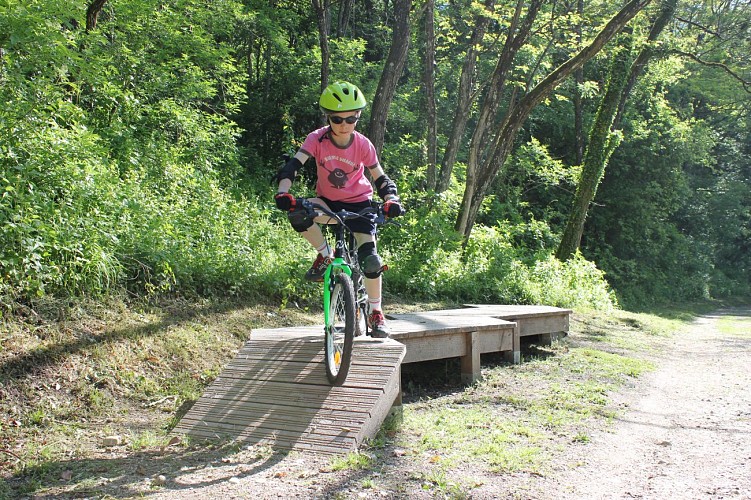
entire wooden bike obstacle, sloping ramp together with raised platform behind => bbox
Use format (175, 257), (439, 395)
(173, 305), (571, 453)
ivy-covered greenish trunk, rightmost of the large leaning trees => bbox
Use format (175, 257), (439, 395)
(556, 35), (631, 260)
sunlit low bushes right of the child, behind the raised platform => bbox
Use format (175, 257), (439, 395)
(379, 197), (617, 309)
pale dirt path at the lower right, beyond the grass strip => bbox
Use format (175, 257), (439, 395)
(531, 309), (751, 499)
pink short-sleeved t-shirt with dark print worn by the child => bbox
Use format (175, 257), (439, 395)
(300, 127), (378, 203)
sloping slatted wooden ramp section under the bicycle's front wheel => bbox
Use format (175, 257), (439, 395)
(173, 326), (406, 454)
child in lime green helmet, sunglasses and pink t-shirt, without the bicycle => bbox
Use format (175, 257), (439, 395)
(274, 82), (404, 338)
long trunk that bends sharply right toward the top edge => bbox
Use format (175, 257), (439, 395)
(456, 0), (651, 238)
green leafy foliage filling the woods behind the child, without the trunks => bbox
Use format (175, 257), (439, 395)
(0, 0), (751, 310)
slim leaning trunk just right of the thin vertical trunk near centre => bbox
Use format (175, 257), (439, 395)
(436, 0), (495, 193)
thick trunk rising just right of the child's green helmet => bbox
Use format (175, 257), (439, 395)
(368, 0), (412, 157)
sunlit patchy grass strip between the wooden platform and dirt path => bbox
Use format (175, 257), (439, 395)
(397, 304), (683, 480)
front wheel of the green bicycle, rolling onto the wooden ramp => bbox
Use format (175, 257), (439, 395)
(324, 273), (357, 385)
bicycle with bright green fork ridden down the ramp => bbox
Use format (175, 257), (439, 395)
(298, 199), (396, 385)
